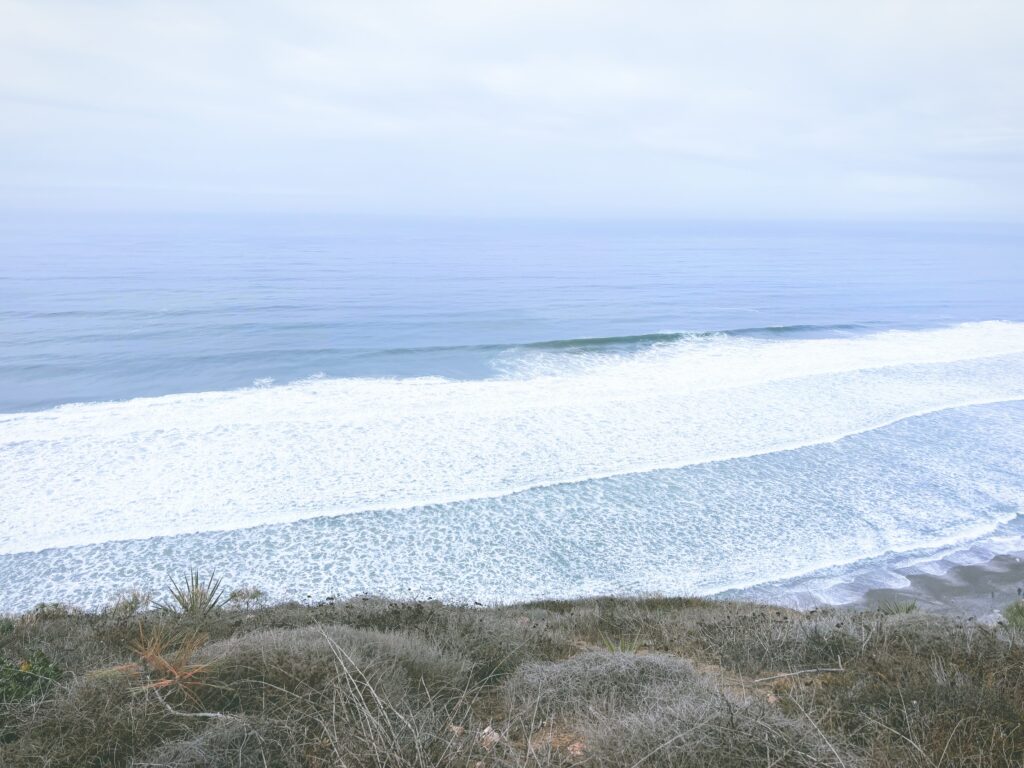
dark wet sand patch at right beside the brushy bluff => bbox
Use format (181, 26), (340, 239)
(855, 553), (1024, 623)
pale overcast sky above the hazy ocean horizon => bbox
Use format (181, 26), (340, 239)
(0, 0), (1024, 221)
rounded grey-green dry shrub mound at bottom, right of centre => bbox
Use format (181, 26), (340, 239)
(505, 651), (841, 767)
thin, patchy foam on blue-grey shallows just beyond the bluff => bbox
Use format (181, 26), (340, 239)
(0, 402), (1024, 610)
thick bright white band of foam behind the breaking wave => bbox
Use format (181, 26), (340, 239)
(0, 323), (1024, 553)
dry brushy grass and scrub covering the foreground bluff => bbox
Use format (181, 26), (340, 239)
(0, 593), (1024, 768)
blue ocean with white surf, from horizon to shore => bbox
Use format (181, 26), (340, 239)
(0, 215), (1024, 610)
